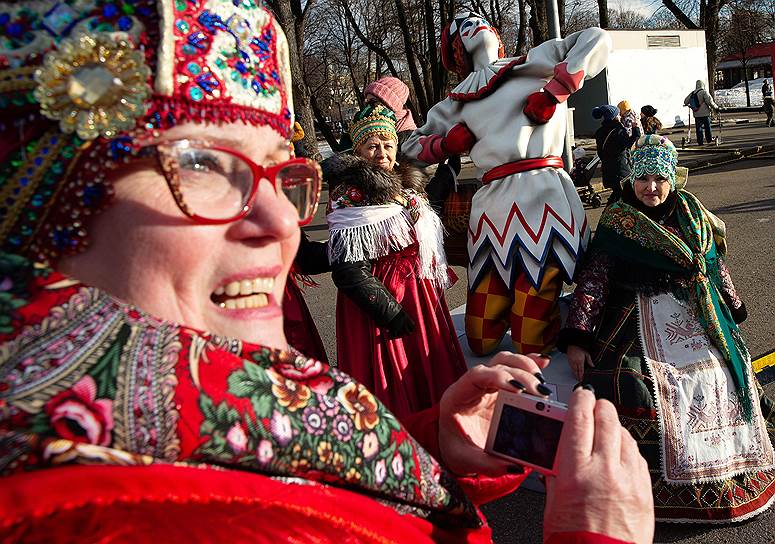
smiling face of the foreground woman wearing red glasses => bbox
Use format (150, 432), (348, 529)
(60, 123), (300, 349)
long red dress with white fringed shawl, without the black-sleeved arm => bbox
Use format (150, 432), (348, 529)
(328, 171), (467, 420)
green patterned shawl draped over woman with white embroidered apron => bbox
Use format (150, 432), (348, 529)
(595, 191), (752, 421)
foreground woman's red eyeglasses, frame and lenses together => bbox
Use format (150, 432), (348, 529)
(149, 140), (323, 226)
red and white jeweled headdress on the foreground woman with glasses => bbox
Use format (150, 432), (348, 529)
(0, 0), (293, 262)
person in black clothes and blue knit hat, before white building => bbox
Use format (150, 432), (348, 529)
(592, 104), (640, 204)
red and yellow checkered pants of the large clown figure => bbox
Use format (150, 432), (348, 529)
(466, 263), (562, 355)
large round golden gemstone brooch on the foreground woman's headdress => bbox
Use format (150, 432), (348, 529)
(35, 33), (151, 140)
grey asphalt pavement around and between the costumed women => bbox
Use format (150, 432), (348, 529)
(305, 114), (775, 544)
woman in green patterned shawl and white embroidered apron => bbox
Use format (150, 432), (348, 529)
(559, 135), (775, 523)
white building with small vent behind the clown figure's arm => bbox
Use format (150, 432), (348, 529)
(569, 30), (708, 135)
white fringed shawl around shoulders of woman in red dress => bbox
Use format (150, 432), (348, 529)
(327, 198), (450, 288)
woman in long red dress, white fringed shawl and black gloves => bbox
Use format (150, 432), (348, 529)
(328, 105), (466, 419)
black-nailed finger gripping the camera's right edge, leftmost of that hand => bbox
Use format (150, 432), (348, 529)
(557, 389), (595, 471)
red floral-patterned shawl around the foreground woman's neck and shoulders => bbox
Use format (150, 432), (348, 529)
(0, 256), (481, 527)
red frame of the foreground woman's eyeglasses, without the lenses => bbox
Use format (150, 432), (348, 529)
(153, 140), (323, 227)
